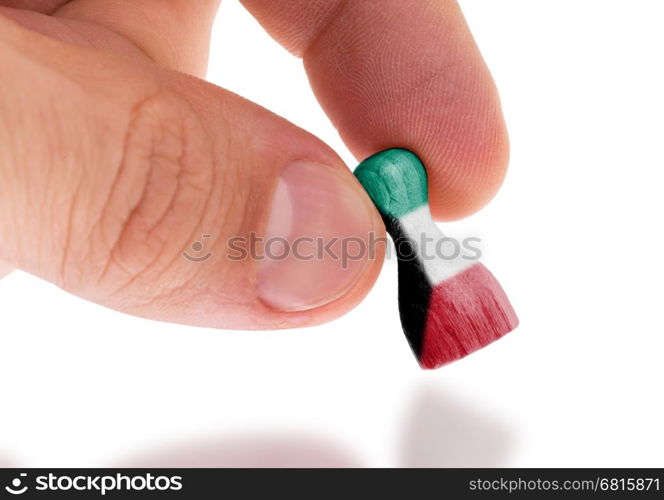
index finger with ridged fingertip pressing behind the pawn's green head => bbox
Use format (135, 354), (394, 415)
(243, 0), (509, 219)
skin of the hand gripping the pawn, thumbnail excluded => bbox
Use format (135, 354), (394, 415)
(0, 0), (508, 329)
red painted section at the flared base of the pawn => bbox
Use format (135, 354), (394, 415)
(419, 262), (519, 369)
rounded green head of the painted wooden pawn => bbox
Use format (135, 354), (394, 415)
(353, 148), (429, 219)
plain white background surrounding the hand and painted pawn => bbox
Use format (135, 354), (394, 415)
(0, 0), (664, 467)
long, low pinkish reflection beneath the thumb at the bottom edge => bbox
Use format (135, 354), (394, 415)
(118, 433), (362, 468)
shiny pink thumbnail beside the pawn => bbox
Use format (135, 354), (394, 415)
(257, 160), (375, 311)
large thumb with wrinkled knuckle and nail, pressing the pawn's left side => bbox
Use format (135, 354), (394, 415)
(0, 21), (384, 328)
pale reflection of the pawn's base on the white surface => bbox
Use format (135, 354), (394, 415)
(398, 385), (514, 467)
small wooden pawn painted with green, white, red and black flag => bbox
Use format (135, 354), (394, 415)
(354, 149), (518, 368)
